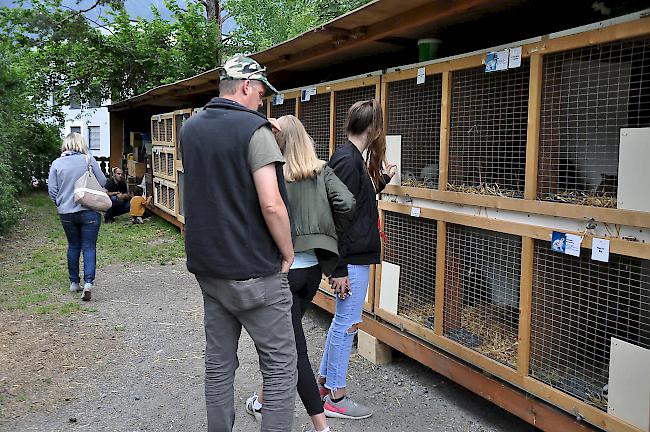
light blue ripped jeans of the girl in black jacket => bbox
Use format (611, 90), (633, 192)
(319, 265), (370, 391)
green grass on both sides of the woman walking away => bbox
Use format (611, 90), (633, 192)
(0, 193), (185, 315)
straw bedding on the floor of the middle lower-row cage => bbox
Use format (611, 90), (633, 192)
(456, 305), (519, 368)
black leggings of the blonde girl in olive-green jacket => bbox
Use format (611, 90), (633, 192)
(289, 265), (323, 416)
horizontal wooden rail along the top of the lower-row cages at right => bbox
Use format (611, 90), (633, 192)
(379, 201), (650, 259)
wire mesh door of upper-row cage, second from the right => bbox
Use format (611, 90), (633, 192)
(448, 59), (530, 198)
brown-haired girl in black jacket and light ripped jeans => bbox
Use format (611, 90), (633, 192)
(318, 100), (394, 419)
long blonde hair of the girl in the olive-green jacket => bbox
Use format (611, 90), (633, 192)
(275, 115), (325, 182)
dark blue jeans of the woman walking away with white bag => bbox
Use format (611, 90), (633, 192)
(59, 210), (102, 283)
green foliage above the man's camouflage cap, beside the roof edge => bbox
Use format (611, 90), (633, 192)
(224, 0), (369, 53)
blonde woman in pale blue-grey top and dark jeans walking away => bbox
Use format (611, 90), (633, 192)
(47, 132), (106, 301)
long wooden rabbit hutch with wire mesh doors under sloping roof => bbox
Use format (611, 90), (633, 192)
(112, 0), (650, 432)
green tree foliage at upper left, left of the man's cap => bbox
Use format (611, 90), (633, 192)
(0, 0), (218, 102)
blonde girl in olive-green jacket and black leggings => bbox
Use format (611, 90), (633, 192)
(246, 115), (355, 432)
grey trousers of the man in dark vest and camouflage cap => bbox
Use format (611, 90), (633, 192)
(196, 273), (297, 432)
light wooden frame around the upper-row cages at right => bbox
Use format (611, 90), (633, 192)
(381, 17), (650, 228)
